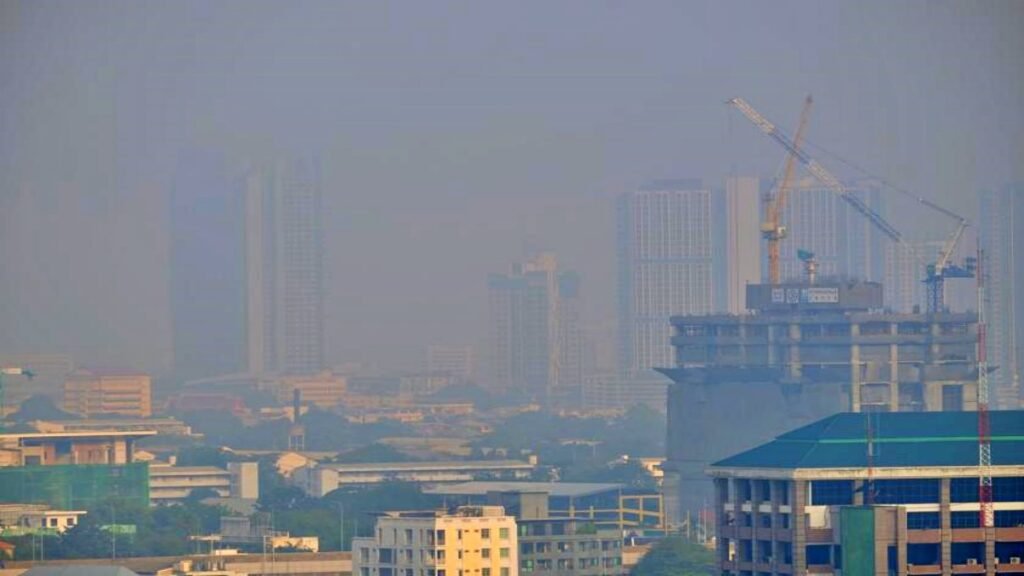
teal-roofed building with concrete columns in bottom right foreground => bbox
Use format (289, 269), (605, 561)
(708, 411), (1024, 576)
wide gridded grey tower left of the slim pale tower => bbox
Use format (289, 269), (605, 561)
(616, 179), (715, 375)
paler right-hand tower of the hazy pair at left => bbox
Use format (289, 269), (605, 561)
(246, 161), (324, 375)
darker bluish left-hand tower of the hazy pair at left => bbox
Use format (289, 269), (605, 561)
(169, 153), (248, 380)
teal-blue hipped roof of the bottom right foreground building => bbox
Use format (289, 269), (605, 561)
(712, 410), (1024, 468)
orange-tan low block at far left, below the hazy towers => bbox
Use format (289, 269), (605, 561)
(63, 370), (153, 417)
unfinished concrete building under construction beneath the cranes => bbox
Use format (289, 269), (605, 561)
(663, 281), (978, 523)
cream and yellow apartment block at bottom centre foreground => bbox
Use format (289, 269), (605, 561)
(352, 506), (519, 576)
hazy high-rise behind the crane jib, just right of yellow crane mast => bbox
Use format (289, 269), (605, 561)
(779, 178), (888, 282)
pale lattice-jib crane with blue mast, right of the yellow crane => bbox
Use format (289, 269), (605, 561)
(726, 98), (977, 313)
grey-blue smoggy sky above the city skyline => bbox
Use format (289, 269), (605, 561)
(0, 0), (1024, 372)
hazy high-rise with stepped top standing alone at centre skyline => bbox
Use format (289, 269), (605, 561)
(487, 253), (583, 401)
